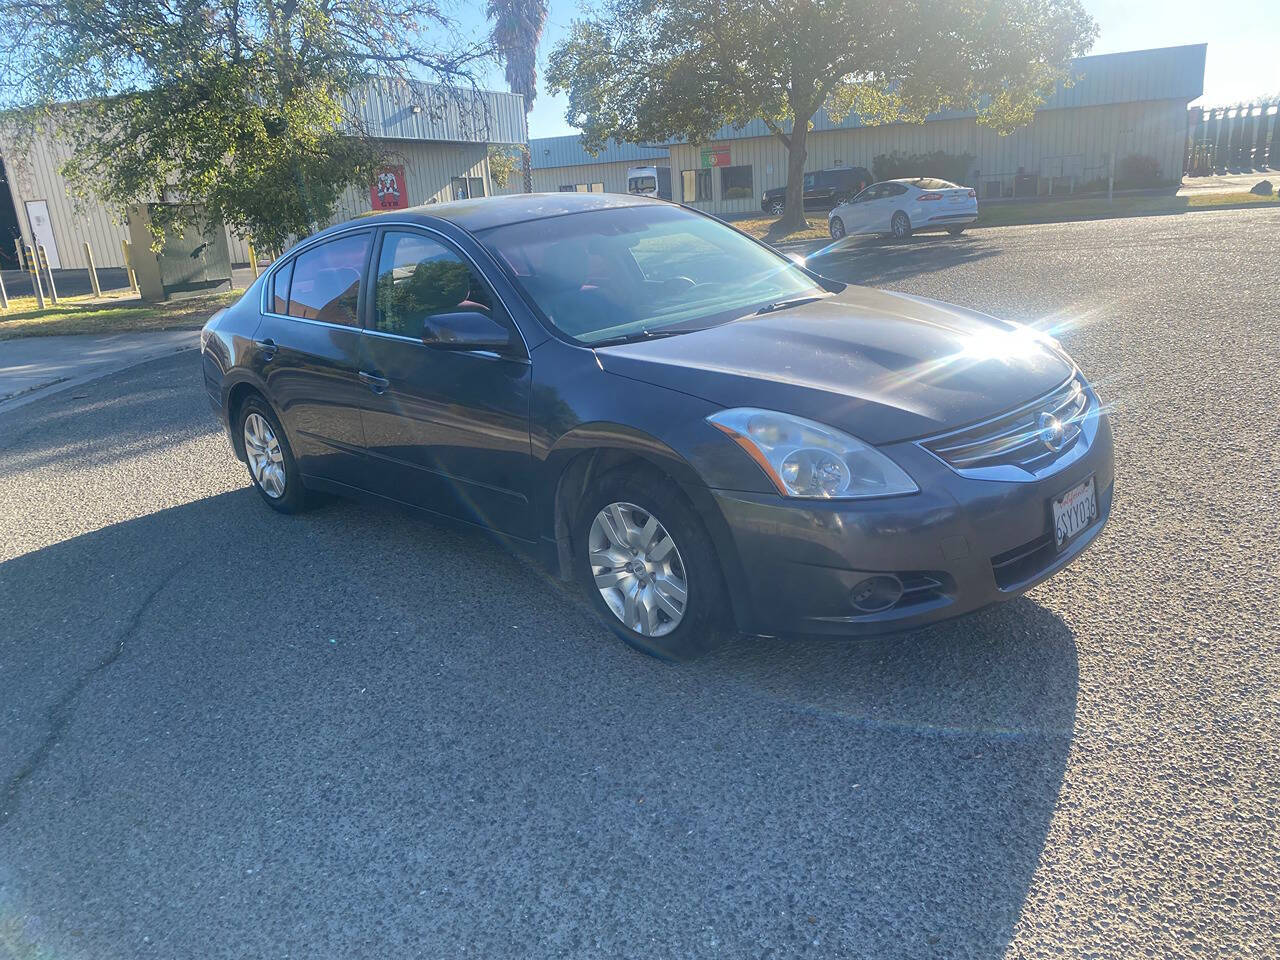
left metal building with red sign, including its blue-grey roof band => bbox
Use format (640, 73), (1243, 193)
(0, 82), (529, 269)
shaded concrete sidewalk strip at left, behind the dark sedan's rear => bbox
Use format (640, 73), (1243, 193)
(0, 330), (200, 413)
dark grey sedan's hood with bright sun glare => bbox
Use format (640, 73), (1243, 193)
(596, 287), (1074, 444)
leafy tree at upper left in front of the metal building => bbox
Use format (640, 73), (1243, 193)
(0, 0), (529, 248)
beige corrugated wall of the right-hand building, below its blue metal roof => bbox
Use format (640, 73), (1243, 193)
(660, 100), (1187, 214)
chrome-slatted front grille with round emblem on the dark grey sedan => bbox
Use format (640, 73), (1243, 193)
(924, 378), (1089, 472)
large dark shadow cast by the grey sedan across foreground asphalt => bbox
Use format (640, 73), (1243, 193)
(0, 488), (1076, 957)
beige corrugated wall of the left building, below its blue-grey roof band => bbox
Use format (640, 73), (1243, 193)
(4, 137), (492, 270)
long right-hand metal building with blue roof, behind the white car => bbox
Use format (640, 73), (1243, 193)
(506, 44), (1204, 214)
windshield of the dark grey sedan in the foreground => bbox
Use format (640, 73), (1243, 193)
(479, 204), (823, 344)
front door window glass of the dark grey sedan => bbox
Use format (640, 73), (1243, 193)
(374, 232), (493, 339)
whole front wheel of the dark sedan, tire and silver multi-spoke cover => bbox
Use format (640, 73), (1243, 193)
(573, 471), (726, 660)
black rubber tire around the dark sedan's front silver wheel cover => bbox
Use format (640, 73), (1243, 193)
(573, 467), (728, 662)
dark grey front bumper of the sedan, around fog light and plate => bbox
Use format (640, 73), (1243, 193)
(712, 416), (1115, 636)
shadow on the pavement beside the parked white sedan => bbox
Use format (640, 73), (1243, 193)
(805, 233), (1001, 287)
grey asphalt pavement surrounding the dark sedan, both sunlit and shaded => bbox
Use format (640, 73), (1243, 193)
(0, 211), (1280, 960)
